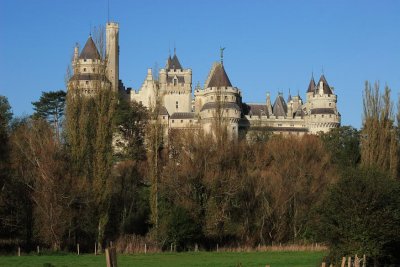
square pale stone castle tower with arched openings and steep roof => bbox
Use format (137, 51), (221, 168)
(159, 50), (192, 114)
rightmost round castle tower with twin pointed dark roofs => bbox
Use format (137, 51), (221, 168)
(306, 75), (341, 134)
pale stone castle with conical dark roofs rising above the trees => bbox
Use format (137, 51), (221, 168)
(68, 22), (341, 138)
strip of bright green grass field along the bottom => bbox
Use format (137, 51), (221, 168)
(0, 251), (326, 267)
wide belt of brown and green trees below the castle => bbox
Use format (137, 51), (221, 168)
(0, 83), (400, 264)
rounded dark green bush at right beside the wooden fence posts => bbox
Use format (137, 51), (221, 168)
(314, 168), (400, 266)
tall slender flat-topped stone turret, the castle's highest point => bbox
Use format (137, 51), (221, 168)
(106, 22), (119, 92)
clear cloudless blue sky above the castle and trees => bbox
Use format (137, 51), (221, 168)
(0, 0), (400, 128)
